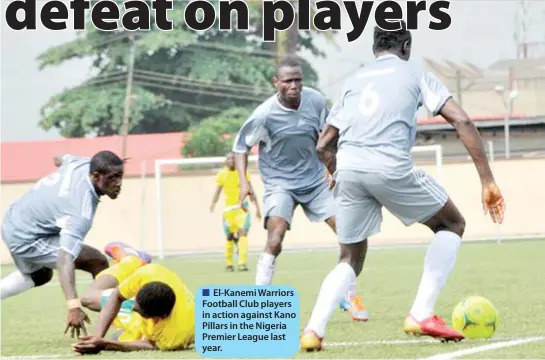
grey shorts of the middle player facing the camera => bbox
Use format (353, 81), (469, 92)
(263, 179), (337, 229)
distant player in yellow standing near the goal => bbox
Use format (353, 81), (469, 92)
(210, 152), (261, 271)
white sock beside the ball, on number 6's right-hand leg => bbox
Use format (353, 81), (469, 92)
(411, 231), (462, 321)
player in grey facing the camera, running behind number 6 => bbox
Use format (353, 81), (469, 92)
(233, 58), (369, 321)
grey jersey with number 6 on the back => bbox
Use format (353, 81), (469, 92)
(327, 55), (451, 173)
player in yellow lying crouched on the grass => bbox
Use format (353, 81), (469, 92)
(73, 243), (195, 354)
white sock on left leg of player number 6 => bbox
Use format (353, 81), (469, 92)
(305, 263), (356, 337)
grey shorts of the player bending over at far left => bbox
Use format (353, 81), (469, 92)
(2, 229), (60, 275)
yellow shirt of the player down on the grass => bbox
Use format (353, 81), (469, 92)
(119, 264), (195, 350)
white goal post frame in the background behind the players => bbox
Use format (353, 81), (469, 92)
(149, 145), (443, 259)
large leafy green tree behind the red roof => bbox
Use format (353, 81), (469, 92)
(38, 0), (332, 137)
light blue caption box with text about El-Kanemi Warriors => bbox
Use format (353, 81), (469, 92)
(195, 286), (299, 358)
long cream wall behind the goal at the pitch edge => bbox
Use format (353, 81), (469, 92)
(0, 158), (545, 264)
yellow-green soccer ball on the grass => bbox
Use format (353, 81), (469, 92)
(452, 296), (499, 339)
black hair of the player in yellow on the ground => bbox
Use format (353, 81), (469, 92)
(135, 281), (176, 318)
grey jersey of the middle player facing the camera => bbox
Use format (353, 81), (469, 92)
(233, 87), (328, 192)
